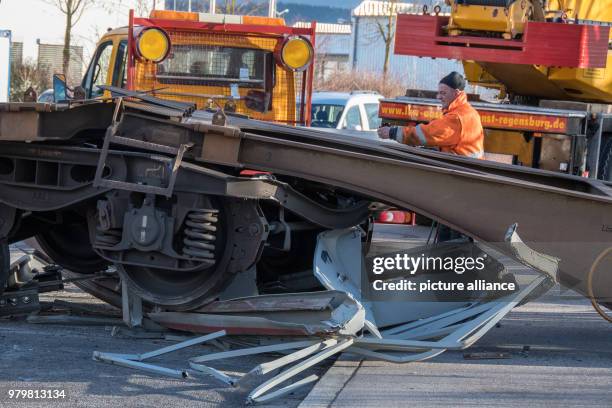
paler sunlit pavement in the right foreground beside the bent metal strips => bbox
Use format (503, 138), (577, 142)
(300, 288), (612, 408)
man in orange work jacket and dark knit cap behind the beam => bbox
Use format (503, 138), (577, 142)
(378, 72), (484, 159)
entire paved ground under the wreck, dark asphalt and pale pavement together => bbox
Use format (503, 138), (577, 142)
(0, 227), (612, 408)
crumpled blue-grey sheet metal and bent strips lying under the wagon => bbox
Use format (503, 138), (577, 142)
(94, 228), (550, 404)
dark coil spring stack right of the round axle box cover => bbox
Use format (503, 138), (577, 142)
(183, 209), (219, 260)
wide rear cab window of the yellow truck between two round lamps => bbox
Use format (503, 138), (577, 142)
(156, 45), (272, 88)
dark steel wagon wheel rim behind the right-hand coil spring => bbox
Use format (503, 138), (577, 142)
(116, 200), (265, 311)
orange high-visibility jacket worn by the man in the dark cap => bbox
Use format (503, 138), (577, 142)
(400, 92), (484, 159)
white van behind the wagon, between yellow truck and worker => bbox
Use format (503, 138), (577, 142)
(312, 91), (383, 131)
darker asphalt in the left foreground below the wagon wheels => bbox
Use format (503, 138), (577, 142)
(0, 287), (331, 408)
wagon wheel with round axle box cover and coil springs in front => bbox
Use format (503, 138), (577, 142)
(88, 192), (267, 311)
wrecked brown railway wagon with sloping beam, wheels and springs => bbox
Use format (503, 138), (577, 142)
(0, 95), (612, 316)
